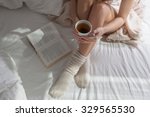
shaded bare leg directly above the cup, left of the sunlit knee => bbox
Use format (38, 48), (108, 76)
(77, 0), (95, 19)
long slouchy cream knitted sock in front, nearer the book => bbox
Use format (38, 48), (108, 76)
(49, 51), (87, 98)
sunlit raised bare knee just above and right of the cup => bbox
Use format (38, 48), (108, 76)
(89, 3), (116, 28)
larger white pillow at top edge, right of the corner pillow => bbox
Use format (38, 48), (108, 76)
(23, 0), (64, 16)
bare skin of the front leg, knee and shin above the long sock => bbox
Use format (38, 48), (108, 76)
(79, 3), (115, 56)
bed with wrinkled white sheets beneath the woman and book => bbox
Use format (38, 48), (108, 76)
(0, 0), (150, 100)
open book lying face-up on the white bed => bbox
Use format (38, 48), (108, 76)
(27, 22), (72, 67)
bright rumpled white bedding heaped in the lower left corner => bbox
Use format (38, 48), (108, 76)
(0, 52), (27, 100)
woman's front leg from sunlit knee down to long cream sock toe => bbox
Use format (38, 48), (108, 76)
(49, 0), (115, 97)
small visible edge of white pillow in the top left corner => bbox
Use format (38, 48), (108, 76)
(0, 0), (23, 9)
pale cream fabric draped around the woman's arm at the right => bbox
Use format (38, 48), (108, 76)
(107, 0), (144, 46)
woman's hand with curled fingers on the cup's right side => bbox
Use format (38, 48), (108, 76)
(93, 27), (105, 38)
